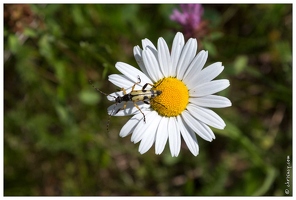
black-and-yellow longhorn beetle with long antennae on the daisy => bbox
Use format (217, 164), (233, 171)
(89, 76), (164, 131)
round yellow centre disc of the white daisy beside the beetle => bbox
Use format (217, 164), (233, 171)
(150, 77), (189, 117)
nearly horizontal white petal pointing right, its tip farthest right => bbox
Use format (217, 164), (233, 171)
(189, 95), (231, 108)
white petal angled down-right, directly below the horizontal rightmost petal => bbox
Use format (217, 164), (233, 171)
(187, 103), (226, 129)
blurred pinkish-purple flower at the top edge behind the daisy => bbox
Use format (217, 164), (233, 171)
(170, 4), (204, 37)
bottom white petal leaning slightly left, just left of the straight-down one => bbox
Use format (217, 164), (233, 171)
(155, 117), (169, 154)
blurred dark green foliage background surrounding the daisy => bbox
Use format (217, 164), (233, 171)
(4, 4), (292, 196)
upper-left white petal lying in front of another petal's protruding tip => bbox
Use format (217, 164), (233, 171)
(143, 49), (163, 82)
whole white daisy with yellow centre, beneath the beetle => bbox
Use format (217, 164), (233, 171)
(107, 32), (231, 157)
